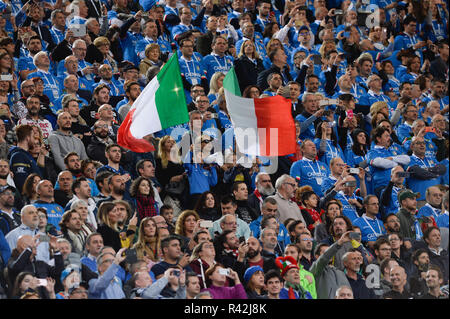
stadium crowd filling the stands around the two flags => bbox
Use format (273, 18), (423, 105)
(0, 0), (449, 299)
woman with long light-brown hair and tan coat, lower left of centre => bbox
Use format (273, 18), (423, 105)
(132, 217), (161, 264)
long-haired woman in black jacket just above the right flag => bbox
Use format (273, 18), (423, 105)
(234, 40), (264, 93)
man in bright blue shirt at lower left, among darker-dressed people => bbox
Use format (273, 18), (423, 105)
(33, 179), (64, 231)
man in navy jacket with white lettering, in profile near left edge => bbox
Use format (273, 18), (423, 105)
(8, 125), (43, 195)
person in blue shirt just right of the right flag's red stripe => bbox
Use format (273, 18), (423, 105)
(314, 121), (345, 166)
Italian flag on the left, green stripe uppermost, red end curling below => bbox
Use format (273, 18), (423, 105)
(117, 53), (189, 153)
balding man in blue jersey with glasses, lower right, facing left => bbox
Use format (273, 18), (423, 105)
(353, 195), (386, 248)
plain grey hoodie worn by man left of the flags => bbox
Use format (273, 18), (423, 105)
(48, 131), (88, 170)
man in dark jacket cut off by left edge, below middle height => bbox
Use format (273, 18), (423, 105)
(0, 185), (20, 235)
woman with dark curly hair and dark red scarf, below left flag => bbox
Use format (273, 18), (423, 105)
(130, 176), (159, 221)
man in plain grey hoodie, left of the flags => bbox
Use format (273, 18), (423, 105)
(48, 112), (88, 170)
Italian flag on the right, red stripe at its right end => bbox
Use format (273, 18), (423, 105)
(223, 68), (296, 156)
